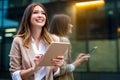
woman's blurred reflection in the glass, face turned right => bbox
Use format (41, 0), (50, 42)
(50, 14), (90, 80)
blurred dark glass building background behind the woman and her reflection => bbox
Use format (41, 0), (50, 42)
(0, 0), (120, 80)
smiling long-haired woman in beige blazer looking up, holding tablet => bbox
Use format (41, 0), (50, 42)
(9, 3), (64, 80)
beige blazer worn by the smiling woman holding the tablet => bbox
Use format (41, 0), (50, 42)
(9, 37), (53, 80)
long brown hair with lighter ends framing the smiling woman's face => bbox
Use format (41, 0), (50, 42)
(15, 3), (52, 46)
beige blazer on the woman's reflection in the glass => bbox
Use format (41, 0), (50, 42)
(55, 37), (74, 80)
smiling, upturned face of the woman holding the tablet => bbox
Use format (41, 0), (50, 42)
(30, 6), (46, 27)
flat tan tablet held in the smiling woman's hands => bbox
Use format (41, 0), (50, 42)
(39, 42), (70, 66)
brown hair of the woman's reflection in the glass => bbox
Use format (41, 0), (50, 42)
(49, 14), (71, 36)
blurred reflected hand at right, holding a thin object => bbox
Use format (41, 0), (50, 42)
(73, 53), (90, 67)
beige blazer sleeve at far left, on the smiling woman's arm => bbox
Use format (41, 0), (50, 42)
(9, 38), (22, 73)
